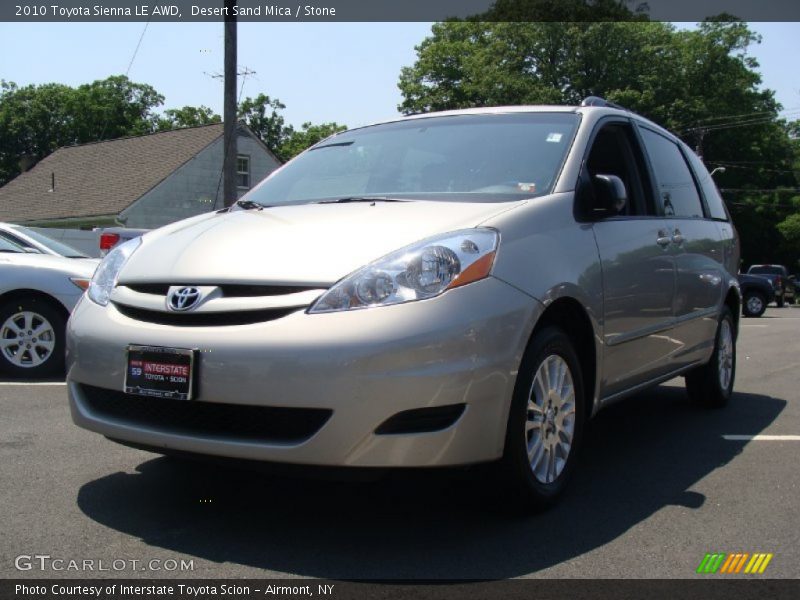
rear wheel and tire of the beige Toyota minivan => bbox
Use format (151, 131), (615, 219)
(686, 307), (736, 408)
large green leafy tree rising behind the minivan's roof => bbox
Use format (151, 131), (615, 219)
(398, 19), (800, 264)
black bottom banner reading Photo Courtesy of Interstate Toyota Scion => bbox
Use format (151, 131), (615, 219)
(0, 577), (800, 600)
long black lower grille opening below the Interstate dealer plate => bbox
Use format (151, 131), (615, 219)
(81, 385), (333, 443)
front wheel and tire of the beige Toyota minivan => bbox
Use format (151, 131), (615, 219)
(500, 326), (585, 511)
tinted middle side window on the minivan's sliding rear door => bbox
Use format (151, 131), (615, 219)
(641, 128), (703, 218)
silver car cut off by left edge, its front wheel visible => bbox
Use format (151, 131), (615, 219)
(0, 238), (99, 378)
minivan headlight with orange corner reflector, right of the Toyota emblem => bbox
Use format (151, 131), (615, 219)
(308, 228), (499, 314)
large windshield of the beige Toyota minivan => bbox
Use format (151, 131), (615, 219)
(246, 112), (578, 206)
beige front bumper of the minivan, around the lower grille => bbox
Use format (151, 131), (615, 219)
(67, 278), (541, 467)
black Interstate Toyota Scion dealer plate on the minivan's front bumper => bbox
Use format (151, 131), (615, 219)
(123, 344), (197, 400)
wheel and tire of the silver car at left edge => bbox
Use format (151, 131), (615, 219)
(0, 298), (66, 379)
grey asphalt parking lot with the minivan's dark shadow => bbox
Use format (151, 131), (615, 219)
(0, 307), (800, 579)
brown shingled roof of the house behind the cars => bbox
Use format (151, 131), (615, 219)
(0, 123), (231, 222)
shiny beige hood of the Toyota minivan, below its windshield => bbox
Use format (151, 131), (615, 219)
(119, 201), (524, 286)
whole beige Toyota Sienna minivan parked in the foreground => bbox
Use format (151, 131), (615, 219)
(67, 98), (740, 507)
